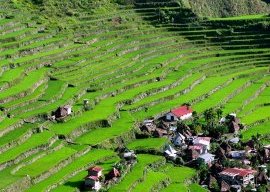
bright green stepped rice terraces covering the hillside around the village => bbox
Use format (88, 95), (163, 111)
(0, 0), (270, 192)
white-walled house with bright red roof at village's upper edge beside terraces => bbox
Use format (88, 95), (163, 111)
(166, 105), (193, 121)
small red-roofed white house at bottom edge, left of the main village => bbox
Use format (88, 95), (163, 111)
(84, 166), (102, 191)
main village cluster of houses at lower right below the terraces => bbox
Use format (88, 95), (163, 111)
(140, 105), (270, 192)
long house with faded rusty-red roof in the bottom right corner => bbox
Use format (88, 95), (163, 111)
(219, 168), (257, 187)
